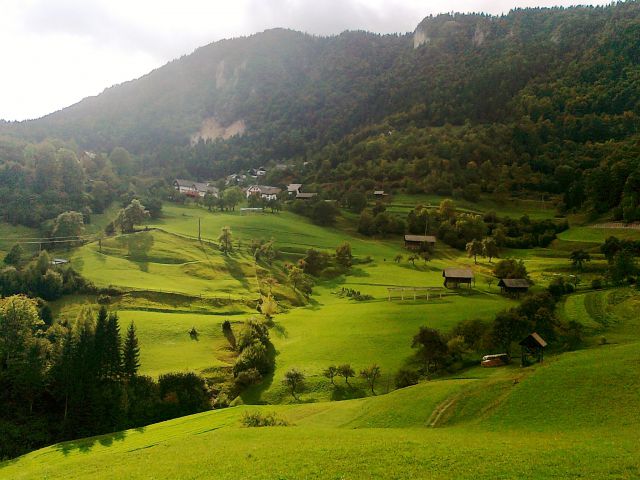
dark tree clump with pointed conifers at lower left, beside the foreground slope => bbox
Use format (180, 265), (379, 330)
(0, 295), (211, 458)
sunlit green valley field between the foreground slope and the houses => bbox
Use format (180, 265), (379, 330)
(58, 205), (512, 394)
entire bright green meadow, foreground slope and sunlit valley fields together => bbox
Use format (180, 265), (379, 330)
(0, 196), (640, 479)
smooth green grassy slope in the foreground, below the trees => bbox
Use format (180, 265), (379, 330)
(0, 338), (640, 479)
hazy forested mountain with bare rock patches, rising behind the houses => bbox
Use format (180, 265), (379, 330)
(0, 2), (640, 220)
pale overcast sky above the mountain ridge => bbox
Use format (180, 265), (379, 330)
(0, 0), (608, 120)
